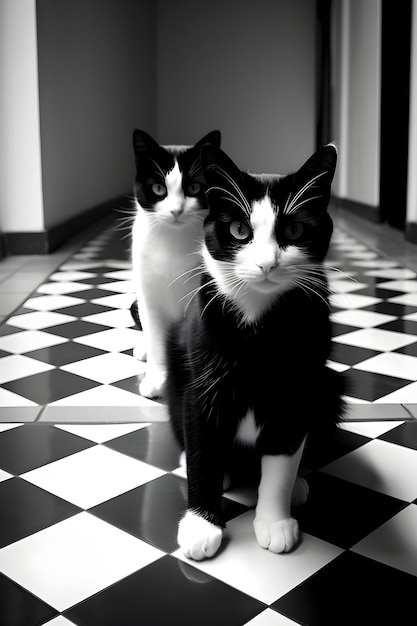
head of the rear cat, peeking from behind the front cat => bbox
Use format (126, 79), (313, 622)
(133, 130), (220, 228)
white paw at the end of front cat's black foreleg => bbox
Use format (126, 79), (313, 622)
(177, 511), (223, 561)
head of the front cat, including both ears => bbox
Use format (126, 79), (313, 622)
(201, 145), (336, 323)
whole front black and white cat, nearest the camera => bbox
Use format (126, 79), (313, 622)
(167, 144), (343, 560)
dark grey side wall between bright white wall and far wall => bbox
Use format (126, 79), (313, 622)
(35, 0), (155, 228)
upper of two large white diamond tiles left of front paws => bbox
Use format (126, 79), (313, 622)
(22, 446), (165, 509)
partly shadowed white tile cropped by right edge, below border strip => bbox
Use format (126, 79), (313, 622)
(321, 439), (417, 502)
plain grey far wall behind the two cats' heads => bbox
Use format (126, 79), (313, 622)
(157, 0), (316, 173)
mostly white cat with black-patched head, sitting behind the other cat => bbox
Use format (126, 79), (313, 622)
(131, 130), (221, 398)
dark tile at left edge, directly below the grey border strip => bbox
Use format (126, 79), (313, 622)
(0, 424), (94, 475)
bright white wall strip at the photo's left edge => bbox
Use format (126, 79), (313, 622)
(0, 0), (44, 232)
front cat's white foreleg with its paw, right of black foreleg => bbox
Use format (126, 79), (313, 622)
(253, 441), (304, 554)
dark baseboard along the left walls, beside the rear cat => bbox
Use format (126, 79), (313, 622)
(0, 196), (129, 258)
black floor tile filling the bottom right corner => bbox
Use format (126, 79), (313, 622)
(272, 552), (416, 626)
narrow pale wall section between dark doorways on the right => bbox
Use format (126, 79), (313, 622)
(333, 0), (381, 207)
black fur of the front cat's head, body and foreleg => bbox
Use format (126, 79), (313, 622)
(167, 146), (343, 526)
